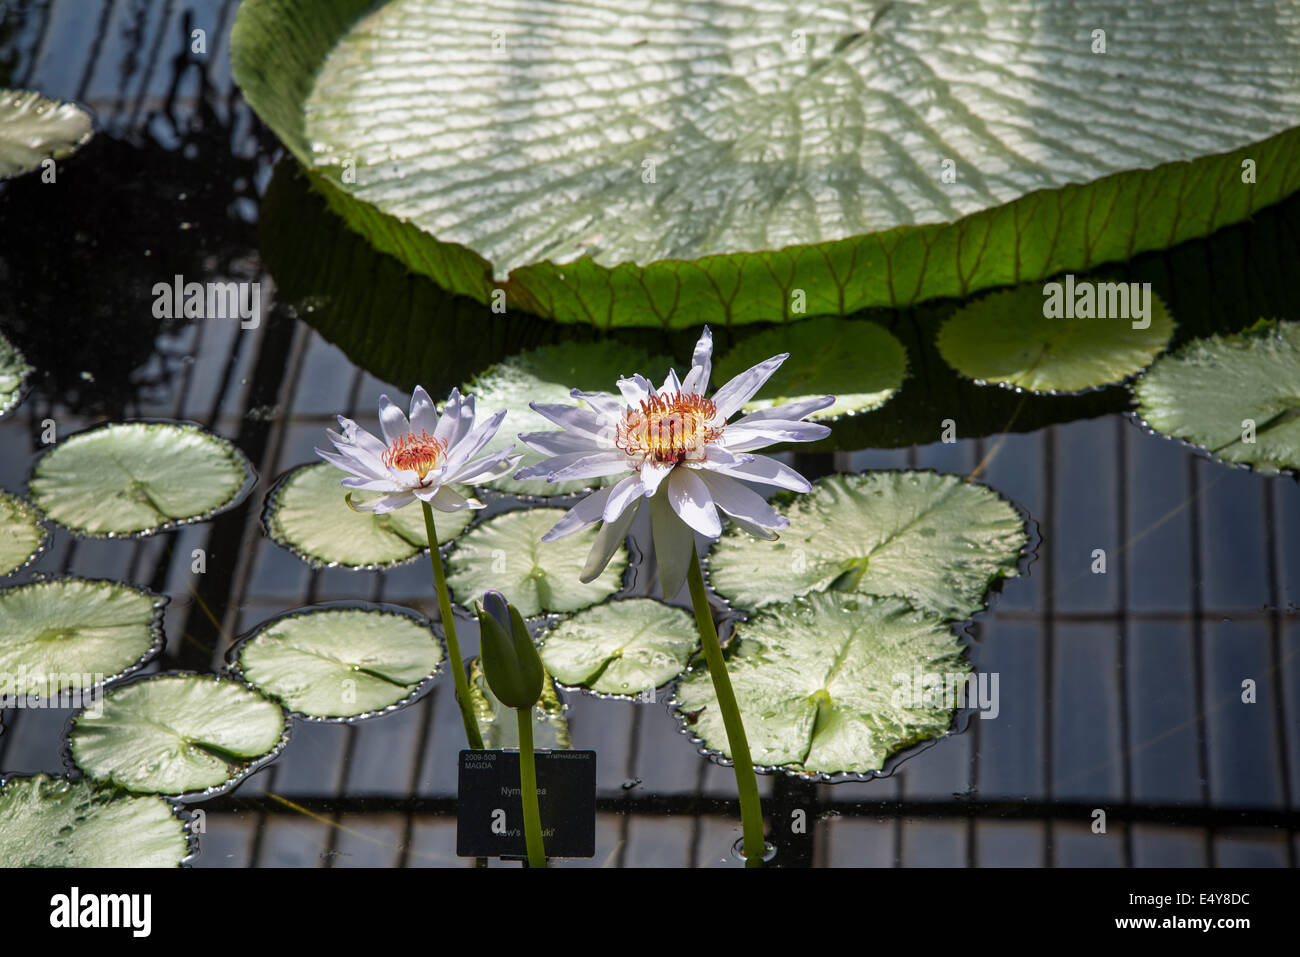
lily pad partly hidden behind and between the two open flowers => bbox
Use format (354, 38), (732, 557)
(464, 339), (670, 495)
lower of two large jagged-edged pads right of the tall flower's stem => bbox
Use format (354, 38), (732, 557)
(673, 594), (975, 775)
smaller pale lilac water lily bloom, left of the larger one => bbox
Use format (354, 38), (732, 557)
(316, 386), (521, 512)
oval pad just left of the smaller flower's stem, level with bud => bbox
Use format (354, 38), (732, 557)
(235, 607), (443, 718)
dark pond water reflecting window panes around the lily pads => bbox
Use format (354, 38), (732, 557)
(0, 0), (1300, 867)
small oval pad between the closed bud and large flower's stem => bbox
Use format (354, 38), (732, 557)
(541, 598), (699, 696)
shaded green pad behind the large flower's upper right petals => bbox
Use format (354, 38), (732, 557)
(714, 317), (907, 420)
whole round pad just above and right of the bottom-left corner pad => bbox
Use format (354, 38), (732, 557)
(68, 674), (285, 794)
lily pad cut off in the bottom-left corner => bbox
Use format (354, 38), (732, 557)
(0, 774), (190, 867)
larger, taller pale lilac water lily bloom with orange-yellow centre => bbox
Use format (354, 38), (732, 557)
(515, 326), (835, 597)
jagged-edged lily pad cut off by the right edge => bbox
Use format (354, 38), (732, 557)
(1134, 321), (1300, 472)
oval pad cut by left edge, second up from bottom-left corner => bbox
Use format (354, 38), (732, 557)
(0, 579), (166, 697)
